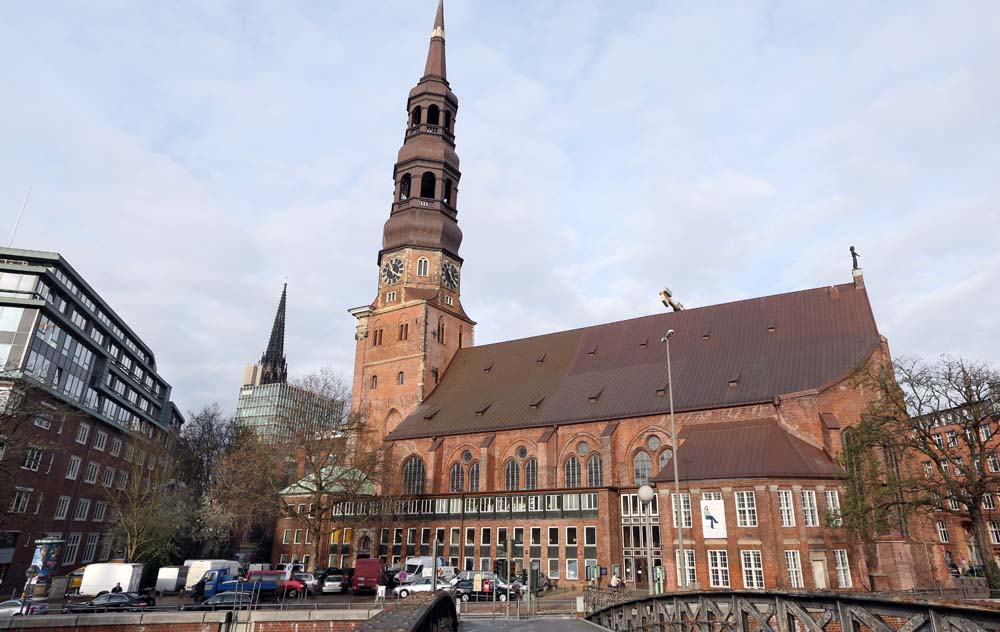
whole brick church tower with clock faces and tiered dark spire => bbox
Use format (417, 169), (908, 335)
(350, 0), (475, 438)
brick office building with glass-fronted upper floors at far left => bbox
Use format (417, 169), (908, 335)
(0, 248), (184, 592)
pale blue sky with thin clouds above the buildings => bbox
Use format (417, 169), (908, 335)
(0, 0), (1000, 412)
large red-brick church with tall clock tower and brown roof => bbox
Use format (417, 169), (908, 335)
(273, 4), (946, 590)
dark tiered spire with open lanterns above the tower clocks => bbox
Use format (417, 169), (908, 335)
(380, 2), (462, 261)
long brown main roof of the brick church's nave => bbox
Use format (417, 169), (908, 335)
(389, 284), (880, 439)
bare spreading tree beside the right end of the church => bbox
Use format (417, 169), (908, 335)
(843, 357), (1000, 589)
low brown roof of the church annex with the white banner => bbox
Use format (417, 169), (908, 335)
(653, 418), (843, 483)
